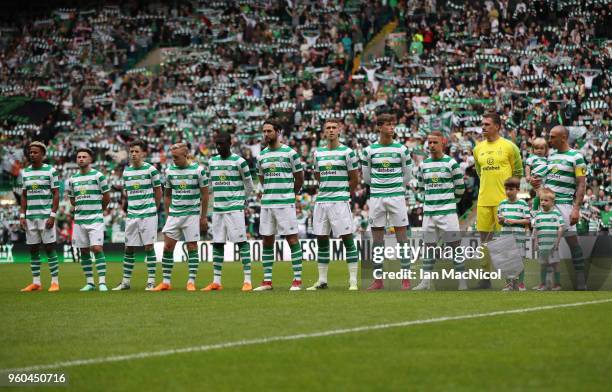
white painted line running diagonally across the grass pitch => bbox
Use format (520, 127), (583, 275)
(0, 298), (612, 374)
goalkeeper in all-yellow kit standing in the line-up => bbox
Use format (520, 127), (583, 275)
(473, 113), (523, 289)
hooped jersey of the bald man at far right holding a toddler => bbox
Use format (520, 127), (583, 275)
(544, 150), (586, 204)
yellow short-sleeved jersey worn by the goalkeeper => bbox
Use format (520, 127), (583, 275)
(474, 137), (523, 206)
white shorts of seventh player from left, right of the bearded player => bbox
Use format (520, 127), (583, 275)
(312, 201), (353, 237)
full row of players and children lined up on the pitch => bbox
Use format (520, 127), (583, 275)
(20, 112), (586, 291)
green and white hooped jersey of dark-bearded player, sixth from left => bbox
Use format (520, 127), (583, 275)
(257, 144), (304, 208)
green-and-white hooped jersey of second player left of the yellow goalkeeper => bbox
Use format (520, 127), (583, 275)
(361, 143), (412, 197)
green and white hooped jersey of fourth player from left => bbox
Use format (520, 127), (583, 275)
(165, 162), (208, 216)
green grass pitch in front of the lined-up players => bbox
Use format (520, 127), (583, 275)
(0, 262), (612, 391)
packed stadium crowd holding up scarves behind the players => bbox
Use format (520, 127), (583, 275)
(0, 0), (612, 242)
